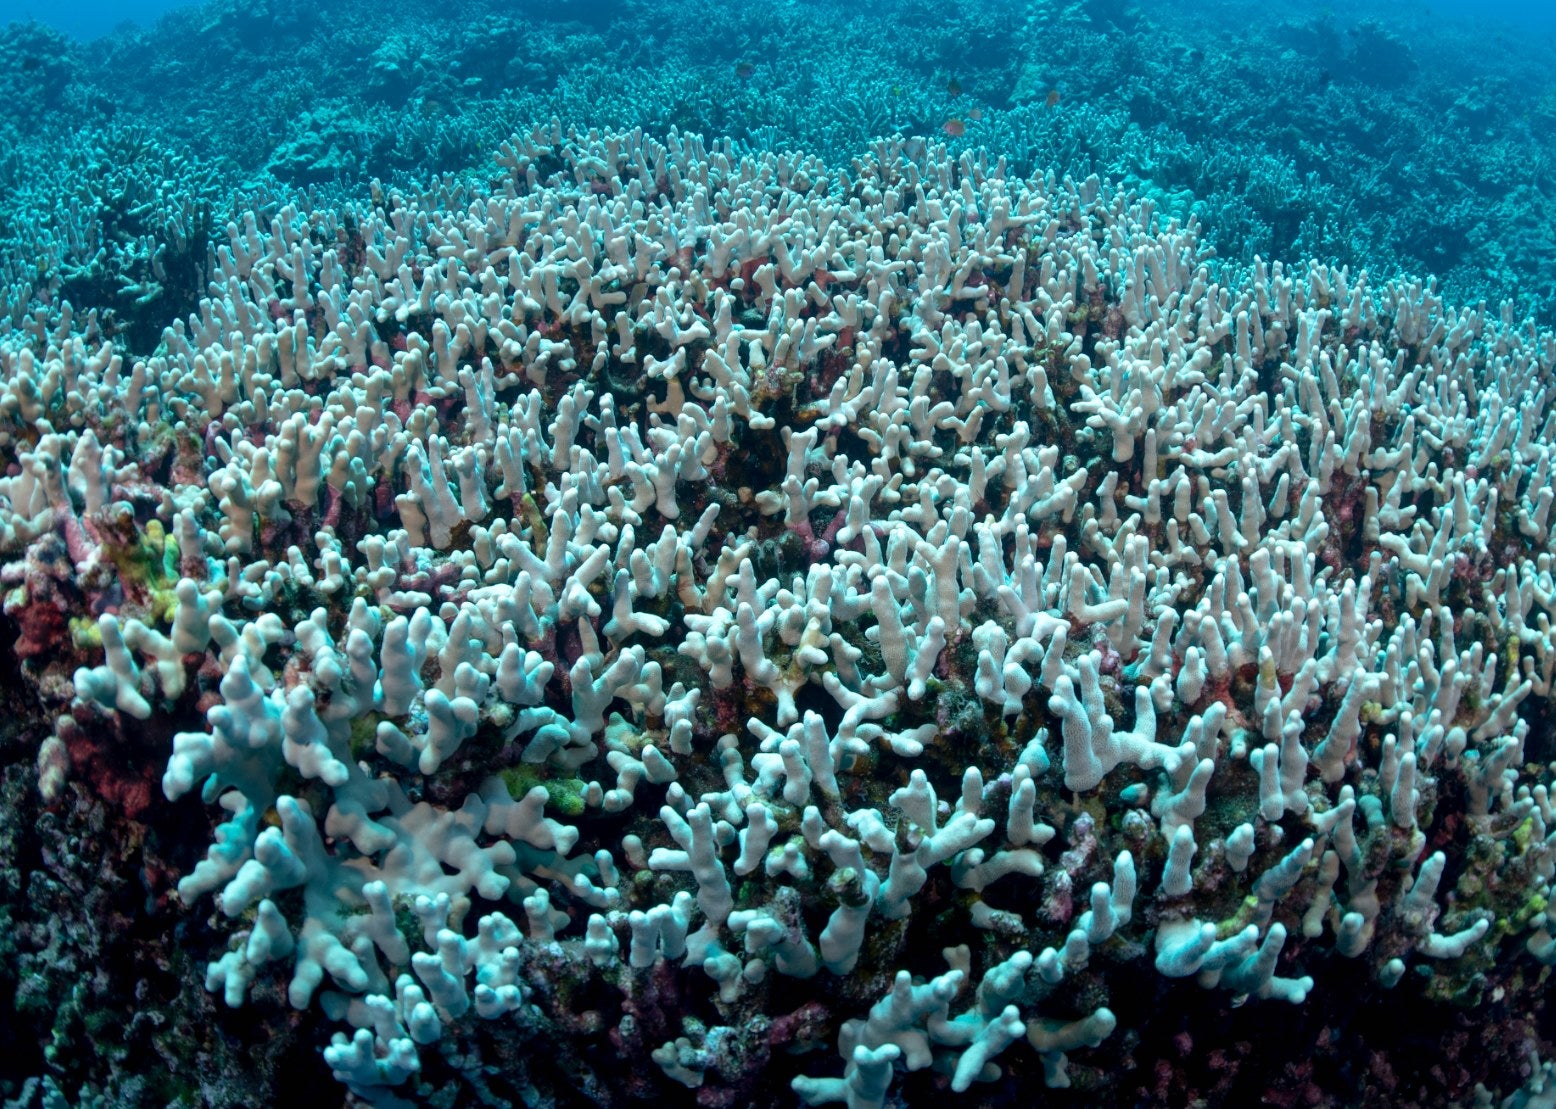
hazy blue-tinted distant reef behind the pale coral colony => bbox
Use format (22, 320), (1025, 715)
(0, 0), (1556, 353)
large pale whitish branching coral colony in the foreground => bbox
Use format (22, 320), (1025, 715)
(0, 126), (1556, 1109)
